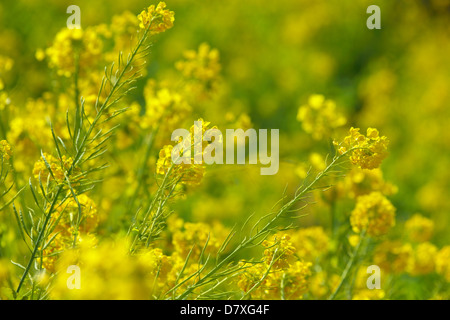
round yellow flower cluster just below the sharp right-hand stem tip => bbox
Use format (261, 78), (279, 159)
(350, 192), (395, 236)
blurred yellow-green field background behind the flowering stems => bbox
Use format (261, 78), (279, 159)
(0, 0), (450, 298)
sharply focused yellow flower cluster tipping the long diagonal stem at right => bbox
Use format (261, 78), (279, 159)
(334, 127), (389, 169)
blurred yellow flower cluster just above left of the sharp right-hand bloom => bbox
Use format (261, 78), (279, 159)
(297, 94), (347, 140)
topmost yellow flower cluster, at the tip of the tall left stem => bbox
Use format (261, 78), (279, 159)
(138, 2), (175, 34)
